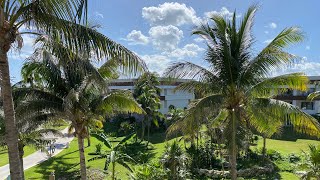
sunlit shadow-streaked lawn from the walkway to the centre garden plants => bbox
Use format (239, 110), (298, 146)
(25, 133), (182, 179)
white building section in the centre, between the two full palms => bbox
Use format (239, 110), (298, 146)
(109, 79), (195, 114)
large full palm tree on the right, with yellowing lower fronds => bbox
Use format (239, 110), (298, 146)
(165, 6), (320, 179)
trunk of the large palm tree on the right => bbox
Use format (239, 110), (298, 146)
(229, 110), (237, 180)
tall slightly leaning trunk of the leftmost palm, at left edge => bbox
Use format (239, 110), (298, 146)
(0, 7), (23, 180)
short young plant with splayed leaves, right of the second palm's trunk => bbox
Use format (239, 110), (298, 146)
(88, 133), (135, 180)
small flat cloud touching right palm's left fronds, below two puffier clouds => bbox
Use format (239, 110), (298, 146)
(167, 43), (204, 59)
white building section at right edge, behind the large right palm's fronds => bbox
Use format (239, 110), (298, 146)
(277, 76), (320, 115)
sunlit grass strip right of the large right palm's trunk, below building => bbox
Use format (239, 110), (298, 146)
(257, 138), (320, 155)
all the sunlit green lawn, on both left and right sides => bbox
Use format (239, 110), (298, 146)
(25, 133), (320, 180)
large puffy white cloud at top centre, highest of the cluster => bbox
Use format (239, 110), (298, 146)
(142, 2), (200, 26)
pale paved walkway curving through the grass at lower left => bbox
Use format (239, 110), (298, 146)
(0, 128), (73, 179)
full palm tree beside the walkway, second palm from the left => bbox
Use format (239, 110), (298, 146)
(20, 39), (143, 179)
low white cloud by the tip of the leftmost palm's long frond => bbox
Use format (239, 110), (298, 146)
(140, 54), (170, 75)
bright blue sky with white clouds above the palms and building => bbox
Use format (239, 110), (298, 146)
(9, 0), (320, 82)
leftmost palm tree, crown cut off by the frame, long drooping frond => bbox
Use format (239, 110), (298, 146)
(0, 0), (146, 180)
